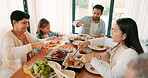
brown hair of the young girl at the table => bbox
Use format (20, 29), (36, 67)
(36, 18), (49, 39)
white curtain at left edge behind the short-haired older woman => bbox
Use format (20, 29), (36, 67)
(0, 0), (24, 78)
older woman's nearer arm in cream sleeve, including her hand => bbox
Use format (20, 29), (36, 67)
(2, 34), (44, 60)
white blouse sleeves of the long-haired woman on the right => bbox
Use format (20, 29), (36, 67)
(90, 38), (138, 78)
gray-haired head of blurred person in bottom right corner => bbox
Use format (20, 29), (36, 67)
(127, 53), (148, 78)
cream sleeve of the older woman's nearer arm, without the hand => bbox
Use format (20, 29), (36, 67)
(3, 38), (32, 60)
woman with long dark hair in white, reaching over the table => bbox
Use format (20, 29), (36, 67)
(79, 18), (143, 78)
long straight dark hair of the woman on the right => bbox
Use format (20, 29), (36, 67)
(116, 18), (143, 54)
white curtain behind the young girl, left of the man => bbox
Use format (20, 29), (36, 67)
(28, 0), (72, 34)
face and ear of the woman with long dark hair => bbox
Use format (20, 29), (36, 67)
(111, 24), (126, 43)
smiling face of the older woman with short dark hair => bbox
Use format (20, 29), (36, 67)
(13, 18), (29, 33)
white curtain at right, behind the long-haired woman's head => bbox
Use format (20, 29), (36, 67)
(125, 0), (148, 42)
